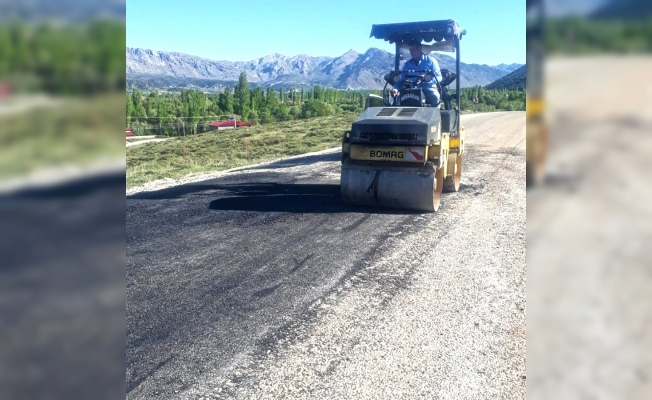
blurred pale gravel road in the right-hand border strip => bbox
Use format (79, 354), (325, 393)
(527, 55), (652, 400)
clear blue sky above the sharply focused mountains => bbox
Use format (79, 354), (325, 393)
(126, 0), (526, 65)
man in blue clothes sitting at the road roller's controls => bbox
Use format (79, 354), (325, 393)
(392, 40), (442, 107)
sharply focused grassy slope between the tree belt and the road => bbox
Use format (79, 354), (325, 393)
(127, 112), (358, 187)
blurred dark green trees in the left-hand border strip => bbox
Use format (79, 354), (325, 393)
(0, 21), (126, 94)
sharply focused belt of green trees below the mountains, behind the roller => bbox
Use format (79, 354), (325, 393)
(126, 73), (525, 136)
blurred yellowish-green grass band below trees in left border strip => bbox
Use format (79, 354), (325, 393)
(0, 93), (125, 180)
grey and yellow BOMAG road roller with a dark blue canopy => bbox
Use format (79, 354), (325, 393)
(341, 20), (466, 212)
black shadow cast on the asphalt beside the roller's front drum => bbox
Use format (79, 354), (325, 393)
(208, 183), (415, 214)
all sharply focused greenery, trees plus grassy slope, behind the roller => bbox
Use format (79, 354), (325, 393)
(126, 70), (525, 187)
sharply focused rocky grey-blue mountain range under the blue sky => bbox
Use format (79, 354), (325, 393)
(126, 47), (523, 90)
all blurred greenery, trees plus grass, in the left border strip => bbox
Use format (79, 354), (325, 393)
(0, 20), (126, 181)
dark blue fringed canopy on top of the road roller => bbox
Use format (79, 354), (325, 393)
(369, 19), (465, 44)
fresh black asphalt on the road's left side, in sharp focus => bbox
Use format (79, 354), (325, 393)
(127, 153), (428, 397)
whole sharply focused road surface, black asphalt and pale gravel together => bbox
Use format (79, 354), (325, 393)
(126, 112), (526, 399)
